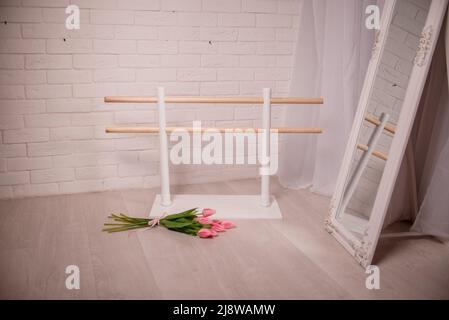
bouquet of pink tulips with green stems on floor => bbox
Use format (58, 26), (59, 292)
(103, 208), (235, 238)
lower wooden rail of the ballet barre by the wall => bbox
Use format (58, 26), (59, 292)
(105, 127), (323, 134)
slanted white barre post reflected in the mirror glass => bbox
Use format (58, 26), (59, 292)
(340, 113), (390, 213)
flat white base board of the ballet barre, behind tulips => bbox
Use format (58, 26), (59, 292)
(150, 194), (282, 219)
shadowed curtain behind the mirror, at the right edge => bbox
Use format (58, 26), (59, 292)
(412, 18), (449, 240)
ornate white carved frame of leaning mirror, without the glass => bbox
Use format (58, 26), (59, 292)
(325, 0), (448, 268)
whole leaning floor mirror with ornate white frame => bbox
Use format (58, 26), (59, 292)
(326, 0), (447, 267)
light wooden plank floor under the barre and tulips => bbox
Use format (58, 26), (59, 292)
(0, 180), (449, 299)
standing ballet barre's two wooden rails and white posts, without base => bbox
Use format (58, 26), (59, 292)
(104, 87), (323, 207)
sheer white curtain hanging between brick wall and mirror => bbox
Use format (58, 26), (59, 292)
(279, 0), (383, 195)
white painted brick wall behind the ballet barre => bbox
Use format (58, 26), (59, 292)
(0, 0), (300, 198)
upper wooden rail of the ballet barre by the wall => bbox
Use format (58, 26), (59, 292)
(104, 96), (323, 104)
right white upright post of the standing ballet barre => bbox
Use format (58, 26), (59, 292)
(260, 88), (271, 207)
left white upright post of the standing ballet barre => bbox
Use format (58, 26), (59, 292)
(157, 87), (171, 207)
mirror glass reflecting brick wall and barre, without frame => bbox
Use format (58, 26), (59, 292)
(337, 0), (431, 239)
